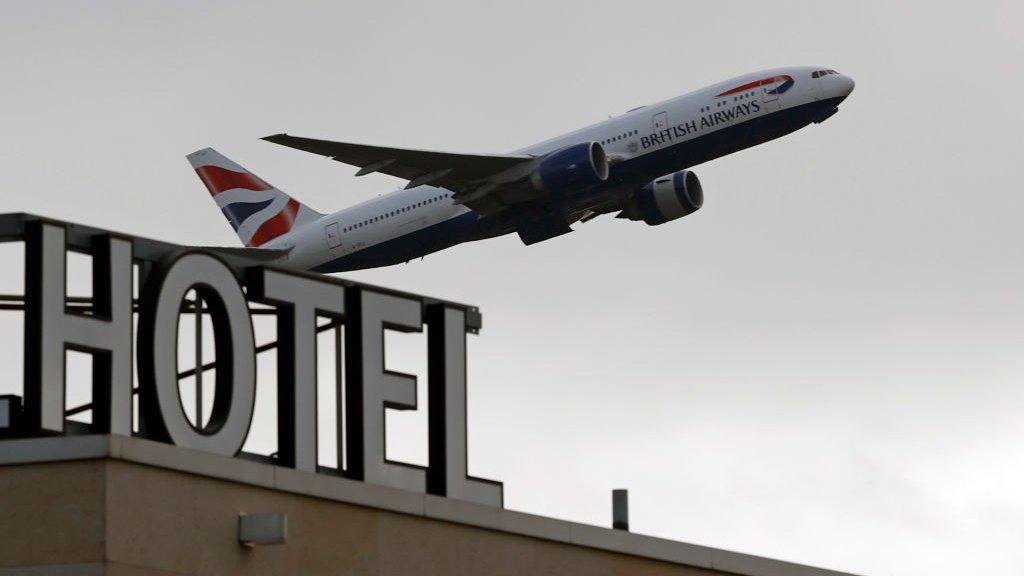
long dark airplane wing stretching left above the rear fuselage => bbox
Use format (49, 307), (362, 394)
(263, 134), (534, 192)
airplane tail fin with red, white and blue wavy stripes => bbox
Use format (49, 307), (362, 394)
(188, 148), (324, 248)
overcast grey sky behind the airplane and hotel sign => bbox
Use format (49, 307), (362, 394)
(0, 0), (1024, 575)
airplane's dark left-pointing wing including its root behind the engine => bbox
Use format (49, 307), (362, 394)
(263, 134), (539, 213)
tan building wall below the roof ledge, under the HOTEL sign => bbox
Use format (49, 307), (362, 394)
(0, 459), (712, 576)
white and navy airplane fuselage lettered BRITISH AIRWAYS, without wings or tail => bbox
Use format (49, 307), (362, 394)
(265, 67), (853, 272)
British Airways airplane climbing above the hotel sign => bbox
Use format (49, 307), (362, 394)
(187, 67), (854, 273)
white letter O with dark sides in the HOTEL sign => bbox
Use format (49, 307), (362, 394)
(138, 252), (256, 456)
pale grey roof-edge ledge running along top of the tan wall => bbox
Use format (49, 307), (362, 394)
(0, 435), (864, 576)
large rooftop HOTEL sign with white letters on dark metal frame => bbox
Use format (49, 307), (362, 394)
(0, 214), (503, 506)
